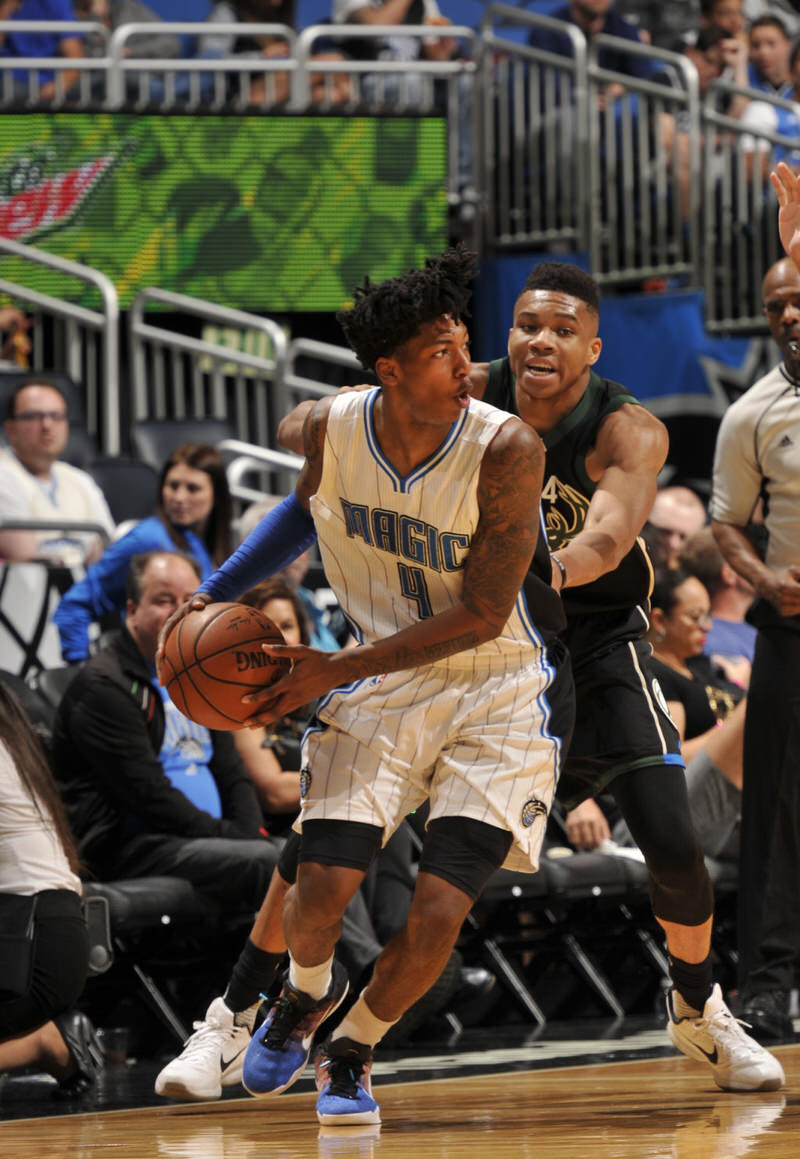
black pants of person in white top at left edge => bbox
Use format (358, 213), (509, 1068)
(0, 889), (89, 1042)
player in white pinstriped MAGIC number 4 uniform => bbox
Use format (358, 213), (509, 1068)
(154, 249), (569, 1124)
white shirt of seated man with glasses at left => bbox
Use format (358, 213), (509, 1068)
(0, 447), (114, 568)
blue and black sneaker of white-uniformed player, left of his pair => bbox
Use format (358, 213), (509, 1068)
(242, 962), (349, 1095)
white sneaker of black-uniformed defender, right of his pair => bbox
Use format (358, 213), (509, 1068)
(667, 984), (786, 1091)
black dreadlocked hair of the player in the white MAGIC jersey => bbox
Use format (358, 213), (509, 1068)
(336, 245), (478, 371)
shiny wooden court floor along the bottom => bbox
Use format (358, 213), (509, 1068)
(0, 1044), (800, 1159)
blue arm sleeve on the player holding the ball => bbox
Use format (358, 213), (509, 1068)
(197, 493), (317, 602)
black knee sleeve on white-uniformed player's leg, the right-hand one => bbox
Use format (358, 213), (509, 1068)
(420, 817), (514, 901)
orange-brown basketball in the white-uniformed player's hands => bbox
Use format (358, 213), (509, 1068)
(161, 604), (290, 730)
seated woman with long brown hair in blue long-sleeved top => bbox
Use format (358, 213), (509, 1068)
(53, 443), (231, 663)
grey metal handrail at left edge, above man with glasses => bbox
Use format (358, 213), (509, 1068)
(0, 238), (121, 454)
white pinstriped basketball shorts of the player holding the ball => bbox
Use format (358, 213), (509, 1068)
(298, 658), (561, 872)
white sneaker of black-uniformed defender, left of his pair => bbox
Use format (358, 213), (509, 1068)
(155, 998), (260, 1099)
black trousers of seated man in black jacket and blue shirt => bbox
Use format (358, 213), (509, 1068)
(109, 833), (283, 912)
